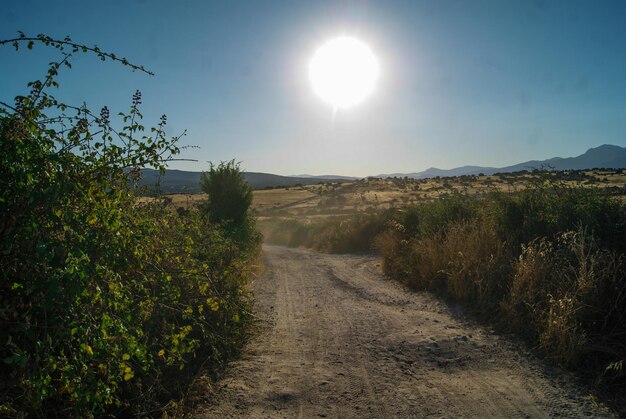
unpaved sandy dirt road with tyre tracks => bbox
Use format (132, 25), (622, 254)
(193, 246), (611, 418)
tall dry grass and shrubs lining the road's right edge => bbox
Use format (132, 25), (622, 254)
(375, 184), (626, 400)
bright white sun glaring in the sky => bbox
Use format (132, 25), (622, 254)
(309, 36), (379, 109)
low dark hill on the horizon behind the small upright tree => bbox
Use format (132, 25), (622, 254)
(139, 169), (348, 193)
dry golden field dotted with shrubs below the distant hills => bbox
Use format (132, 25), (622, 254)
(158, 170), (626, 221)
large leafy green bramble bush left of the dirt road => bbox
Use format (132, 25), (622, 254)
(0, 35), (253, 417)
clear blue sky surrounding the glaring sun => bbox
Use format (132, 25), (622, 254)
(0, 0), (626, 176)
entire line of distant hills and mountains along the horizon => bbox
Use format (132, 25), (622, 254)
(139, 144), (626, 193)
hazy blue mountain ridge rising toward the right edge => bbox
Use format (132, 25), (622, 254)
(377, 144), (626, 179)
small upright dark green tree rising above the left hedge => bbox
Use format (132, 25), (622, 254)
(200, 160), (252, 224)
